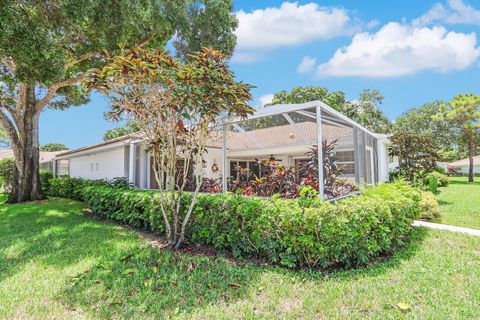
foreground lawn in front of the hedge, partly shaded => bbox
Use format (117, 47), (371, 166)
(0, 199), (480, 319)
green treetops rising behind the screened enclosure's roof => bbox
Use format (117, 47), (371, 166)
(266, 86), (391, 133)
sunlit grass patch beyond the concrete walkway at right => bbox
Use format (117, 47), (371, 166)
(437, 177), (480, 229)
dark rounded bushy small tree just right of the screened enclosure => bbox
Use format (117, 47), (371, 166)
(389, 131), (438, 182)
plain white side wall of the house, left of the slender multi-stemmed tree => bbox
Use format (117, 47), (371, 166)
(69, 146), (125, 179)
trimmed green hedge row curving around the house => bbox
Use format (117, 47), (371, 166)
(50, 178), (421, 268)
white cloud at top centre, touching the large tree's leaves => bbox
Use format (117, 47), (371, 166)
(233, 2), (359, 62)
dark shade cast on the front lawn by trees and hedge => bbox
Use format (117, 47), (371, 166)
(0, 199), (428, 318)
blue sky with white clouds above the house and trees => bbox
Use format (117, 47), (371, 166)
(40, 0), (480, 148)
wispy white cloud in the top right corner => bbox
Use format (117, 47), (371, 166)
(413, 0), (480, 26)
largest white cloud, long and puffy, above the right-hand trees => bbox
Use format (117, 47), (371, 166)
(317, 22), (480, 77)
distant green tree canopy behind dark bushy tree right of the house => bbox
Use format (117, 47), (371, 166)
(393, 101), (467, 162)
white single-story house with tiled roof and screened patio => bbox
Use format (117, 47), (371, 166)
(54, 101), (390, 199)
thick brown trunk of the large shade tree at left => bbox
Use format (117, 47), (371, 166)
(8, 87), (45, 203)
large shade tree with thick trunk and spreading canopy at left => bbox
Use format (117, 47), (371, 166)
(0, 0), (236, 202)
